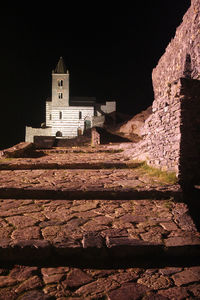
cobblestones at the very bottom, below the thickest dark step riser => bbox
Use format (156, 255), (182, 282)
(0, 265), (200, 300)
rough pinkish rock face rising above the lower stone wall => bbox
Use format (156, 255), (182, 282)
(152, 0), (200, 99)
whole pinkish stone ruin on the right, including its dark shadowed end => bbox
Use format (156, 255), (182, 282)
(128, 0), (200, 185)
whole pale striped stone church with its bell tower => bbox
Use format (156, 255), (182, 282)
(25, 57), (116, 142)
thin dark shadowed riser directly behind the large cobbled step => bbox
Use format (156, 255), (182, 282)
(0, 187), (182, 200)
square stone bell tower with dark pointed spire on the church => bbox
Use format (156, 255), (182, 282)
(52, 56), (69, 107)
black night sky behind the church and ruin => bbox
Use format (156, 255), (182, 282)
(0, 0), (190, 149)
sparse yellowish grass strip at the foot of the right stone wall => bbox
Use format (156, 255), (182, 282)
(134, 162), (178, 184)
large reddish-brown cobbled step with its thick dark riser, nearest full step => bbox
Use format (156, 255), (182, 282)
(0, 199), (200, 267)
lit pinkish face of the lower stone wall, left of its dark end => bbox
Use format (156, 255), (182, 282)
(144, 80), (181, 174)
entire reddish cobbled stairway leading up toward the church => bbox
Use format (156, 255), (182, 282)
(0, 147), (200, 300)
